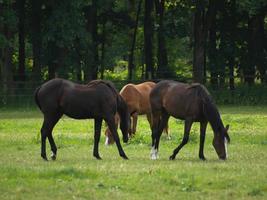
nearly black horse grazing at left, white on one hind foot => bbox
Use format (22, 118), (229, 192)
(35, 78), (130, 160)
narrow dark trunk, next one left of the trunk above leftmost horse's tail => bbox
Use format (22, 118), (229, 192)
(17, 0), (25, 81)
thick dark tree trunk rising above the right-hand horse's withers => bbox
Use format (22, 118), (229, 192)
(193, 1), (206, 83)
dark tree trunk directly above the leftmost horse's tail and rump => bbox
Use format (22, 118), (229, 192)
(31, 0), (42, 81)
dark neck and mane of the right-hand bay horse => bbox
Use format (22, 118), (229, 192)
(191, 84), (224, 133)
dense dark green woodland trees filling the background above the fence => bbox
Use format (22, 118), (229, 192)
(0, 0), (267, 90)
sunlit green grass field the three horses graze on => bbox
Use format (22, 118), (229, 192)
(0, 106), (267, 200)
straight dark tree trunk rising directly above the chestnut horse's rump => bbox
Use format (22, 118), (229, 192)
(144, 0), (154, 79)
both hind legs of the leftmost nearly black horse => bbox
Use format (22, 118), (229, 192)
(41, 114), (62, 160)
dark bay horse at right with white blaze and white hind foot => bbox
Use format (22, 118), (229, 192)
(150, 80), (230, 160)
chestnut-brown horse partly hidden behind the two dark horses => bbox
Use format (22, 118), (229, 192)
(105, 81), (168, 145)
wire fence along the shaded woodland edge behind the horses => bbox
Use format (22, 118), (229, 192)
(0, 76), (267, 109)
